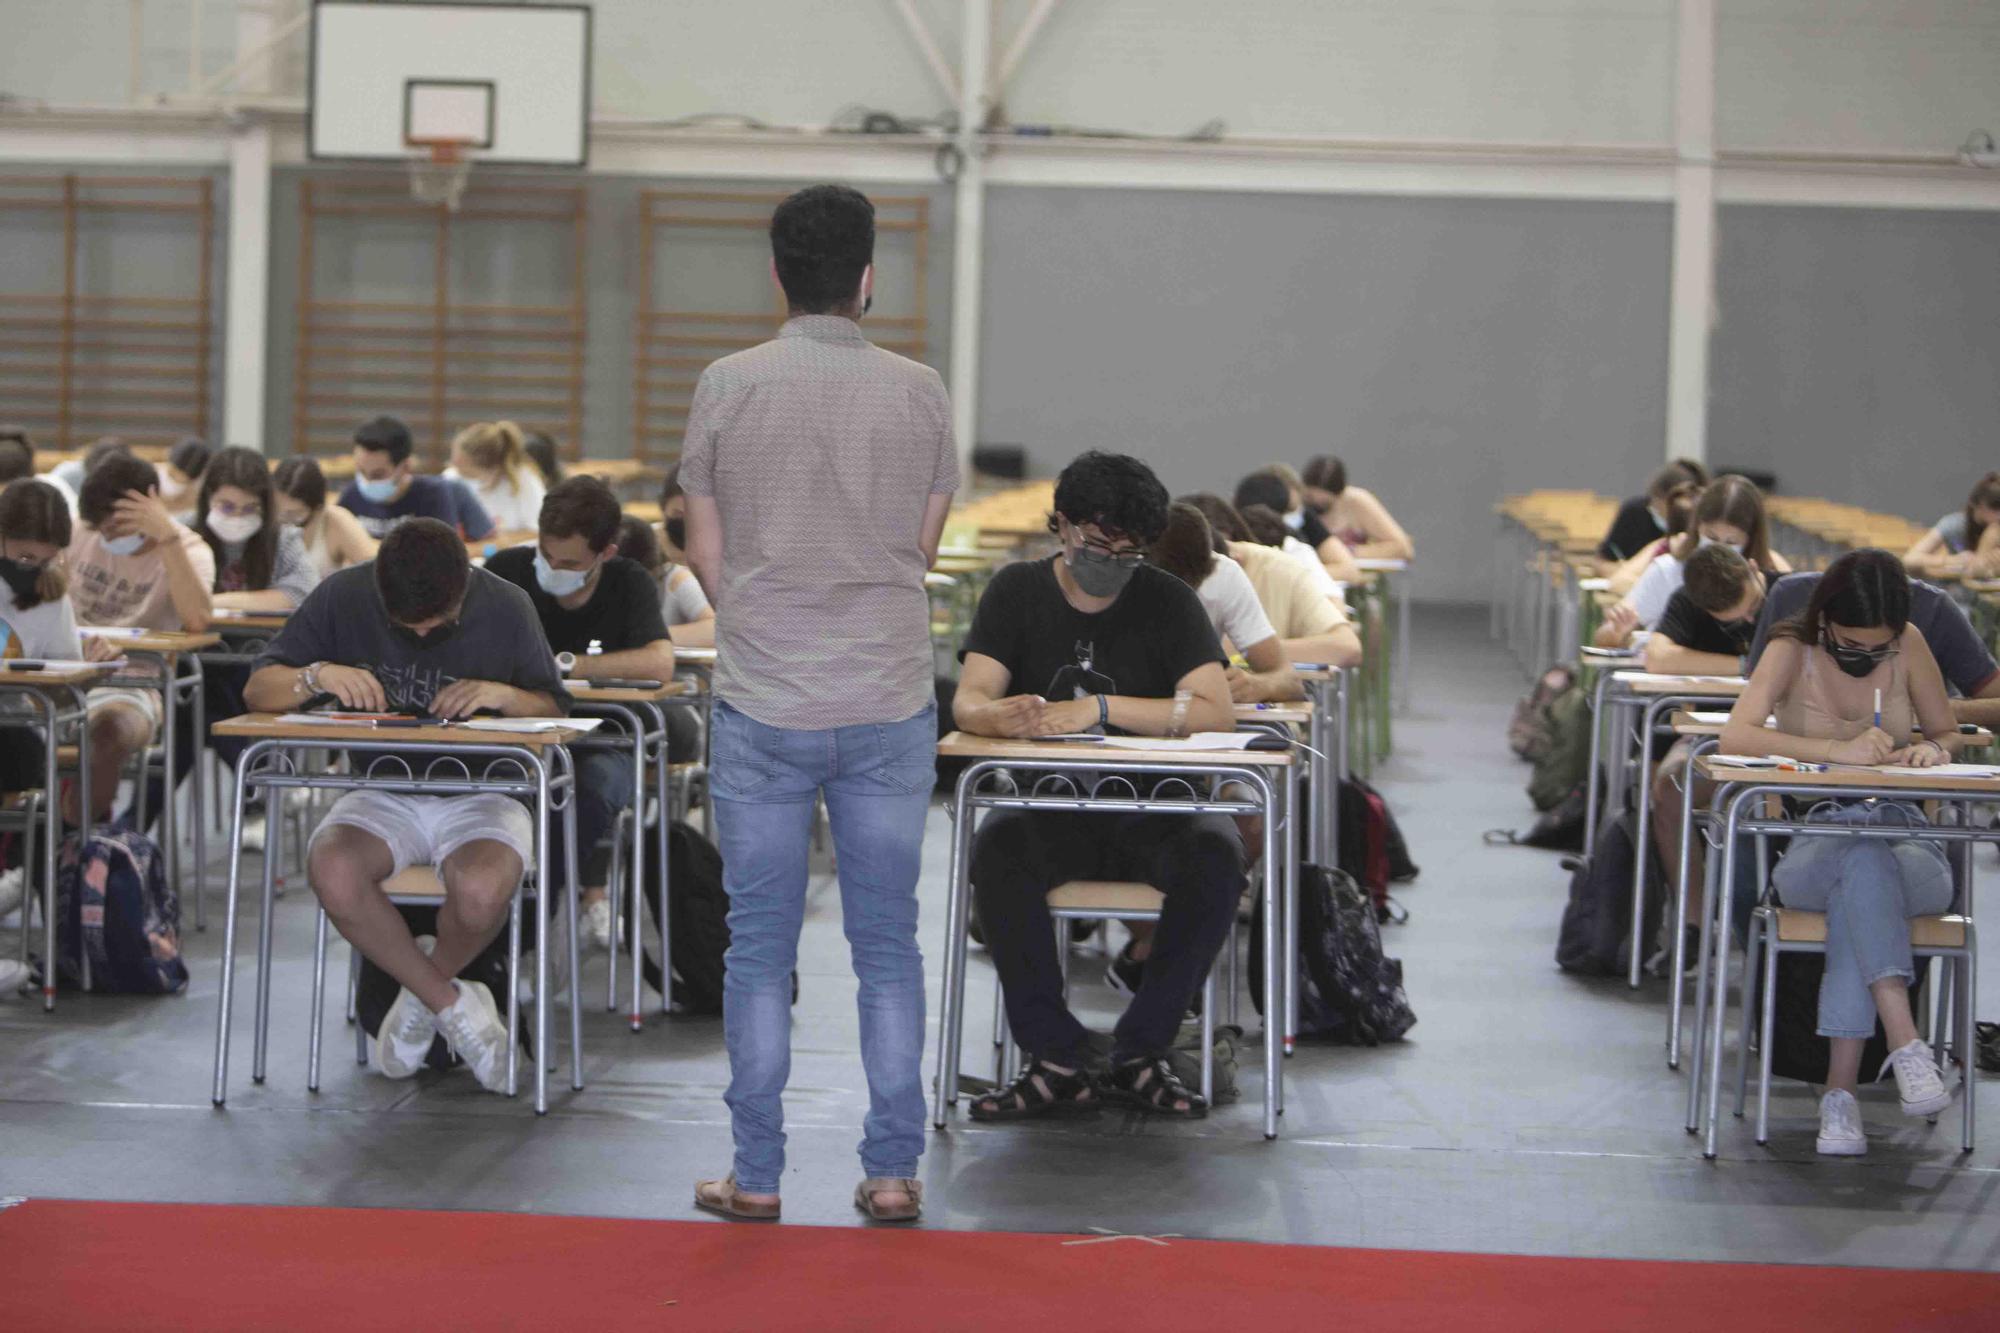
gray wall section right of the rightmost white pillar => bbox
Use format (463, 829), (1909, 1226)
(1708, 206), (2000, 522)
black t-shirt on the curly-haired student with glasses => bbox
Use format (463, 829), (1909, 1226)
(958, 556), (1228, 732)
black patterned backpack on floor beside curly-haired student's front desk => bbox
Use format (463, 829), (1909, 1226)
(1250, 865), (1416, 1047)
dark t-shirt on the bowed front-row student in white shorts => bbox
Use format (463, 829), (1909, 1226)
(256, 560), (570, 773)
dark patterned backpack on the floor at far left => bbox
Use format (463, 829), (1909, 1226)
(56, 825), (188, 995)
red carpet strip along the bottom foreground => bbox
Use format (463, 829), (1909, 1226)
(0, 1199), (2000, 1333)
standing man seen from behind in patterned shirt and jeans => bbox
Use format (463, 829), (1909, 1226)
(680, 186), (958, 1221)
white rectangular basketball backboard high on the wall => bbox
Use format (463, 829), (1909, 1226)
(306, 0), (590, 166)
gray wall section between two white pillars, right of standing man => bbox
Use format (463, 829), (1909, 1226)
(980, 188), (1672, 600)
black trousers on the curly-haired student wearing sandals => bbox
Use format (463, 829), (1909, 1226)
(972, 811), (1244, 1065)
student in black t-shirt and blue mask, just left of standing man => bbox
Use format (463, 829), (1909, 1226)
(486, 476), (692, 949)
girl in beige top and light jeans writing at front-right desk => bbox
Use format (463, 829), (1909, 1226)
(1722, 550), (1958, 1157)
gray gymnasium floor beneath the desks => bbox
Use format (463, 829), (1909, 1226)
(0, 610), (2000, 1269)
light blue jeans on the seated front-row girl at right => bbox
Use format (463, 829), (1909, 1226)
(1770, 803), (1952, 1037)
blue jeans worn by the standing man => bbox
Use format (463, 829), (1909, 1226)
(710, 701), (938, 1195)
